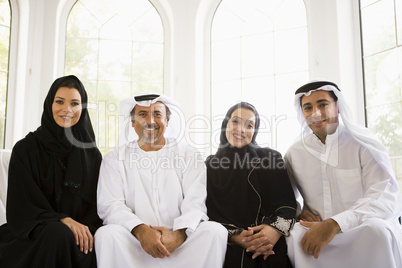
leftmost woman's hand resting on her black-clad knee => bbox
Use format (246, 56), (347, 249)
(60, 217), (94, 254)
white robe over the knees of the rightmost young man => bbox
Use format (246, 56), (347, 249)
(286, 218), (402, 268)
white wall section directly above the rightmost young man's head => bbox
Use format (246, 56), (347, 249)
(305, 0), (365, 124)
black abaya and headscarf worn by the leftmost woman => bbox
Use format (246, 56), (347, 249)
(0, 76), (102, 267)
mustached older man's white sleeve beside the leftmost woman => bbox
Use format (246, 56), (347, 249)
(97, 151), (143, 232)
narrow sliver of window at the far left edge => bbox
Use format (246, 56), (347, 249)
(0, 0), (11, 148)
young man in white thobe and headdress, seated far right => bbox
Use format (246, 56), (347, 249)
(285, 80), (402, 268)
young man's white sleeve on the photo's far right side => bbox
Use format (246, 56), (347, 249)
(331, 149), (398, 232)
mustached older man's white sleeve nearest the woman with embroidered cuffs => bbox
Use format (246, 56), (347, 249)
(173, 149), (208, 235)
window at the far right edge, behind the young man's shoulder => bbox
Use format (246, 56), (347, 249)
(360, 0), (402, 187)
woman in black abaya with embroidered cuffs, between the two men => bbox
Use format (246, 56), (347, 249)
(206, 102), (296, 268)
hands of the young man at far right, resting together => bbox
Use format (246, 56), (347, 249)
(297, 210), (341, 259)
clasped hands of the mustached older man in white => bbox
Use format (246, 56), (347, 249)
(131, 224), (187, 259)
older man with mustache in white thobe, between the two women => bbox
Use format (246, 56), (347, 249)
(95, 94), (227, 268)
